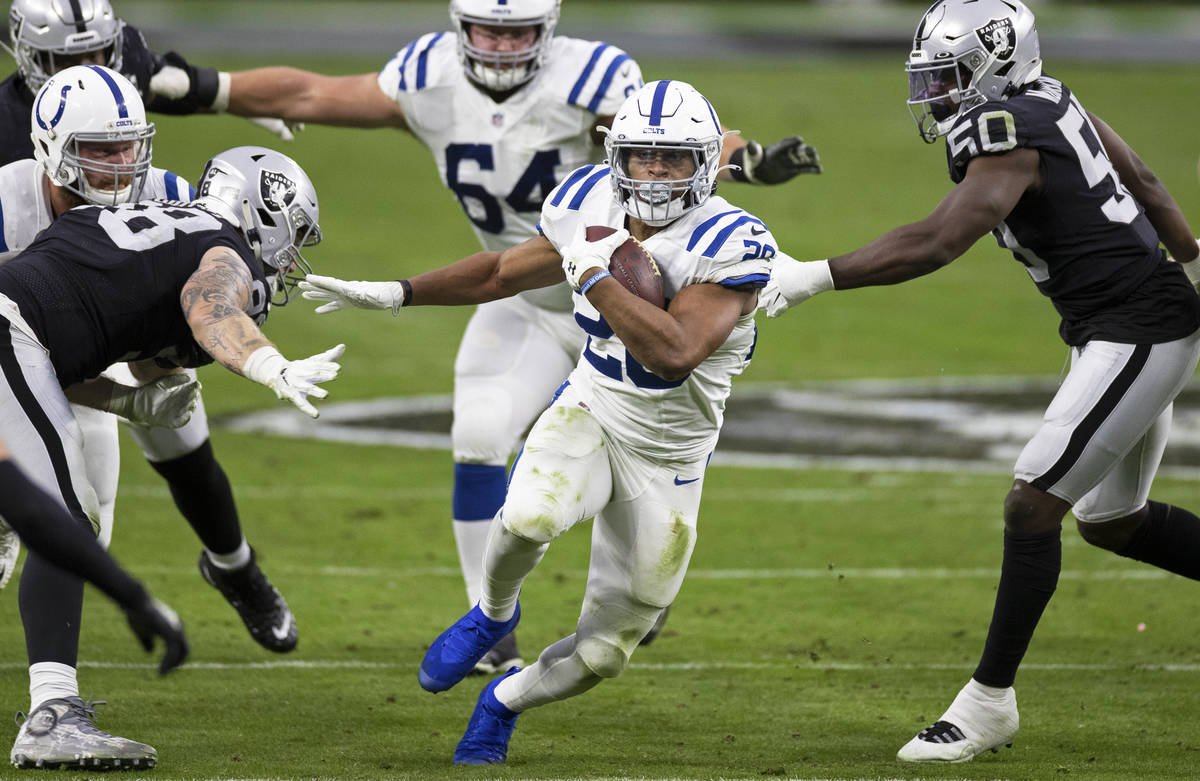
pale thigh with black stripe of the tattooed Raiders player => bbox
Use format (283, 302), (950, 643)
(0, 319), (100, 531)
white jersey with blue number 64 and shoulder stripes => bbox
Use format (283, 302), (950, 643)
(379, 32), (642, 311)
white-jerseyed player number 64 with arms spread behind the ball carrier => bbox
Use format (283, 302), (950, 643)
(184, 0), (821, 673)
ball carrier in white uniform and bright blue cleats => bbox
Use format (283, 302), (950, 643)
(300, 80), (775, 764)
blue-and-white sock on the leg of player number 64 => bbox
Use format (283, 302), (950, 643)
(452, 463), (508, 605)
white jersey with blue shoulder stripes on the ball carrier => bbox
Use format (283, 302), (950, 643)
(541, 166), (776, 461)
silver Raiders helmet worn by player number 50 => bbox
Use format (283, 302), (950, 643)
(905, 0), (1042, 144)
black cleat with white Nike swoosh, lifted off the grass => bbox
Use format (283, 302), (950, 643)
(199, 551), (299, 654)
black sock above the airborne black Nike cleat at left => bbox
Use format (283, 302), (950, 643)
(150, 439), (242, 553)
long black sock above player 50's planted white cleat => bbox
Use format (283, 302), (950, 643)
(973, 528), (1062, 689)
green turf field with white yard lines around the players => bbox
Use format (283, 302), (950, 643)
(0, 52), (1200, 781)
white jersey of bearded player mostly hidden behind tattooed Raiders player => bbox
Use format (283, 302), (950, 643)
(0, 158), (196, 263)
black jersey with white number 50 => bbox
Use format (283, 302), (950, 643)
(946, 77), (1200, 346)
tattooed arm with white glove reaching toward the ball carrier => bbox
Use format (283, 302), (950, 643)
(179, 247), (346, 417)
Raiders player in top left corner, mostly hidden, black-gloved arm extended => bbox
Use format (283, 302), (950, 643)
(0, 0), (292, 166)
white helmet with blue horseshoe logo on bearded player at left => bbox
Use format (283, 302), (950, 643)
(30, 65), (155, 206)
